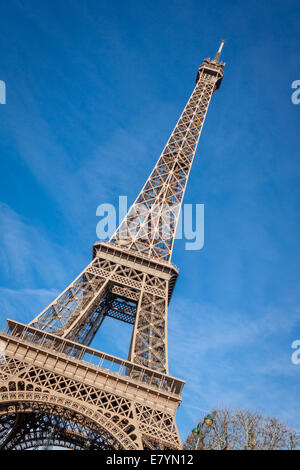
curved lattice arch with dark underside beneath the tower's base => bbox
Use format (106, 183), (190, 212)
(0, 392), (141, 450)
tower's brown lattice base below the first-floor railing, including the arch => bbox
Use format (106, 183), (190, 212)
(0, 332), (182, 450)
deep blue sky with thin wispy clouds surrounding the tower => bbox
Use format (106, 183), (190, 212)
(0, 0), (300, 438)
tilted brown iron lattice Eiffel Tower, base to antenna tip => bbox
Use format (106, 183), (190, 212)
(0, 41), (225, 450)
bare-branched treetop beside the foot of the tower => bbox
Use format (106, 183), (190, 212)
(183, 409), (300, 450)
